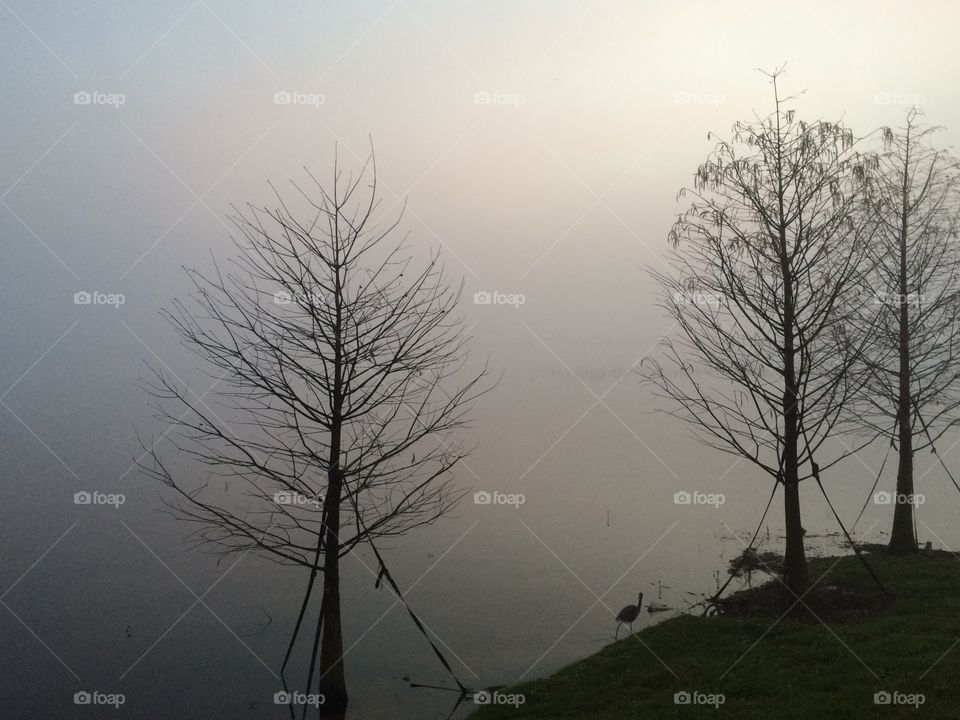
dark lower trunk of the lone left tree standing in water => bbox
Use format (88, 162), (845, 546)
(318, 468), (347, 716)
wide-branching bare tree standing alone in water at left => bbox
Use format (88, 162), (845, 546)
(141, 153), (485, 714)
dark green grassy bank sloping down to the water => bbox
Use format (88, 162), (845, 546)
(470, 552), (960, 720)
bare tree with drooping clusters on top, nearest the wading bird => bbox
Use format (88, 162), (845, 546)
(643, 70), (866, 593)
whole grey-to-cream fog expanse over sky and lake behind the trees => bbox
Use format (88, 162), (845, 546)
(0, 0), (960, 718)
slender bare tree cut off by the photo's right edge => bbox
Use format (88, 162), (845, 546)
(858, 109), (960, 551)
